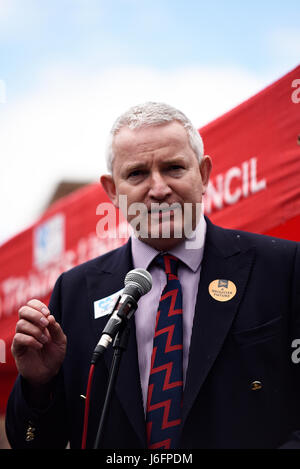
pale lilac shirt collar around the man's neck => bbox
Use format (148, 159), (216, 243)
(131, 215), (206, 272)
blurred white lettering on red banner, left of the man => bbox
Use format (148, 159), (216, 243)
(0, 233), (123, 319)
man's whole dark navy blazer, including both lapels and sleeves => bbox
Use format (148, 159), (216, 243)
(6, 220), (300, 449)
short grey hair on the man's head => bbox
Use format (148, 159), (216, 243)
(106, 101), (204, 173)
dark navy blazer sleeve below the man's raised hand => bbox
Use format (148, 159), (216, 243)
(6, 274), (68, 449)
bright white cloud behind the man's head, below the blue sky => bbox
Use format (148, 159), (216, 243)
(0, 67), (268, 242)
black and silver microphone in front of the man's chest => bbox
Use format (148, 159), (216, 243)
(91, 269), (152, 364)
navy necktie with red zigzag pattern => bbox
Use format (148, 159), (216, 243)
(146, 254), (183, 449)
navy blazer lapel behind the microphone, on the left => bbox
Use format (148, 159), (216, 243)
(86, 240), (146, 445)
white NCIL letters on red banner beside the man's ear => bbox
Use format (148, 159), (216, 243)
(204, 158), (267, 213)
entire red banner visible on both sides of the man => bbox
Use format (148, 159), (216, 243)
(0, 67), (300, 413)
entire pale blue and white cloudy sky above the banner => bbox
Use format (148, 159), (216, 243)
(0, 0), (300, 243)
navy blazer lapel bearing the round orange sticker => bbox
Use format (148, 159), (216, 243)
(182, 220), (254, 425)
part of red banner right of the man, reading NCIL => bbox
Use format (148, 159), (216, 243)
(200, 66), (300, 234)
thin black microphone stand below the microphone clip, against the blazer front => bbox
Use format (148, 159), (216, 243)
(94, 324), (130, 449)
